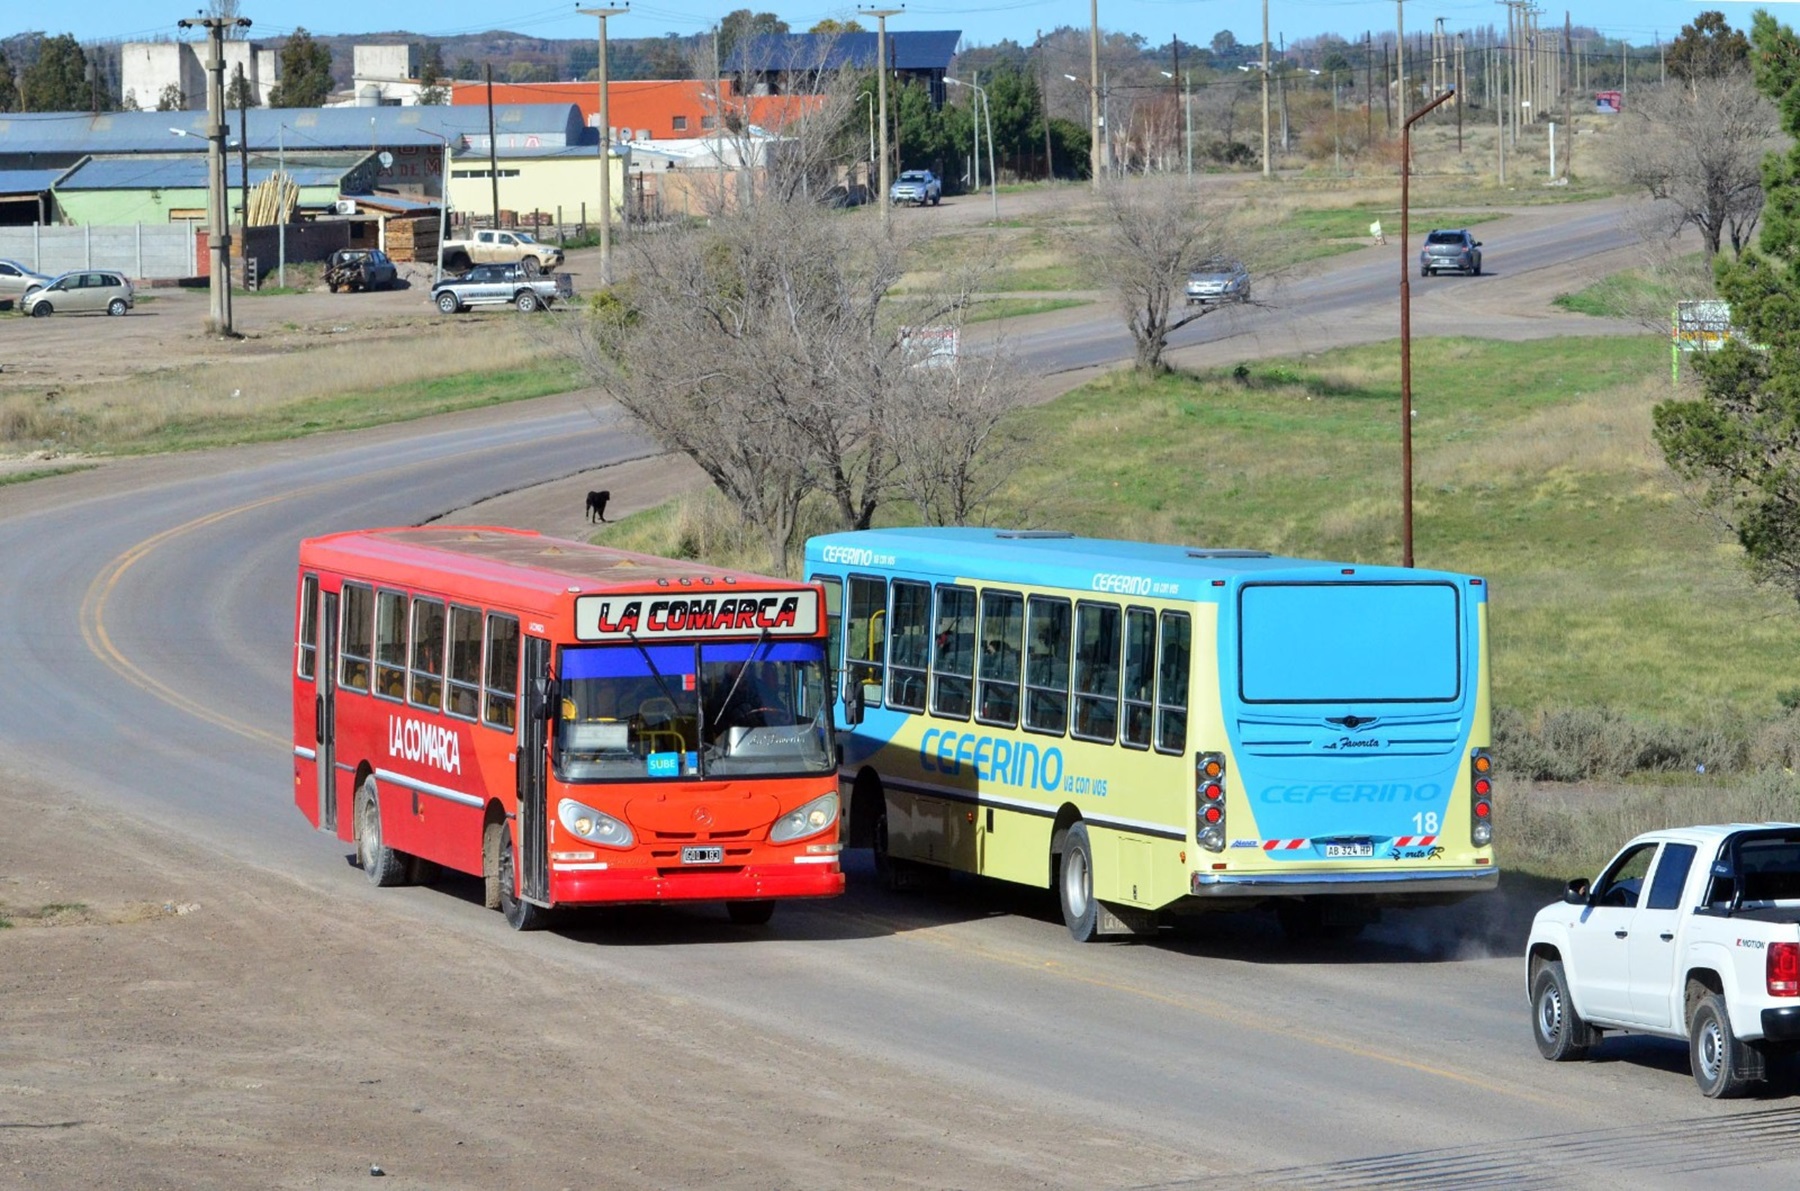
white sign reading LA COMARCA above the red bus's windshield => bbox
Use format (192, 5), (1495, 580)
(574, 588), (819, 640)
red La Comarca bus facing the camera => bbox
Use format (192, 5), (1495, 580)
(293, 527), (844, 930)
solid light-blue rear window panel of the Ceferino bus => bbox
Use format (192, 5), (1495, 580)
(1238, 583), (1462, 703)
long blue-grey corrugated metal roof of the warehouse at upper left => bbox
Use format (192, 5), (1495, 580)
(0, 103), (585, 157)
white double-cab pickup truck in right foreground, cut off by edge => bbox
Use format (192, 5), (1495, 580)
(1525, 824), (1800, 1097)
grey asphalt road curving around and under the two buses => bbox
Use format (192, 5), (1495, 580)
(0, 200), (1800, 1187)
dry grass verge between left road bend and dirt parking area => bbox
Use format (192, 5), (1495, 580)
(0, 322), (561, 453)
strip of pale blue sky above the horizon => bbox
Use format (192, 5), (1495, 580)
(38, 0), (1771, 53)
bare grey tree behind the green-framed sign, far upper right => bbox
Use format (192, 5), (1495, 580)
(1607, 72), (1780, 257)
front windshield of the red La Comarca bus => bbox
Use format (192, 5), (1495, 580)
(554, 640), (835, 781)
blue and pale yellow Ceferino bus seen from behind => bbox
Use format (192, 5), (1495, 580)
(806, 529), (1499, 941)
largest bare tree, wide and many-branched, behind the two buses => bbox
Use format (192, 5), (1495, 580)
(565, 187), (1019, 570)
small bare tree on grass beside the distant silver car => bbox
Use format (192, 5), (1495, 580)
(1084, 176), (1260, 372)
